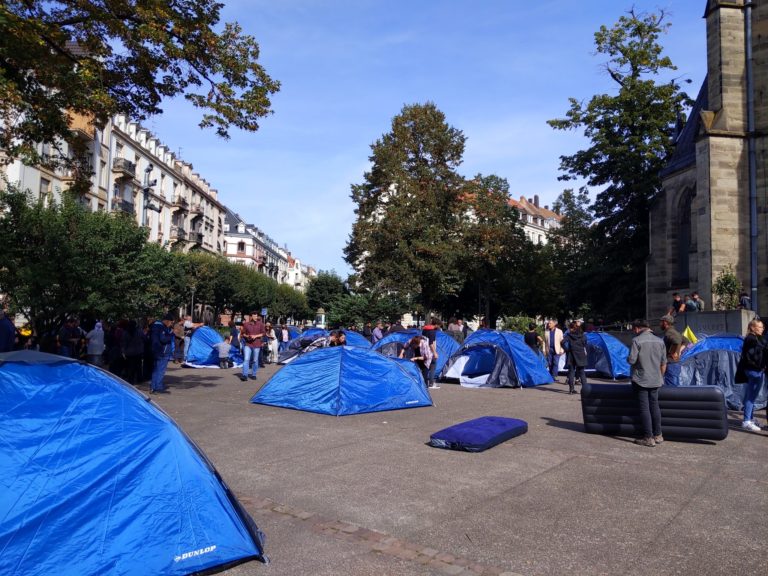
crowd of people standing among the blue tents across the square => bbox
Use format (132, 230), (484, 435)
(0, 304), (768, 446)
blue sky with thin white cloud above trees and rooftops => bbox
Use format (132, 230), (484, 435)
(144, 0), (706, 276)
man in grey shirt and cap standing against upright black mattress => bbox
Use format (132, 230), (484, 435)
(627, 320), (667, 448)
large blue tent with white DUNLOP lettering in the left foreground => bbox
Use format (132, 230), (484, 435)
(0, 351), (266, 576)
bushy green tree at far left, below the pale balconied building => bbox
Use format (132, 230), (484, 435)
(0, 186), (183, 334)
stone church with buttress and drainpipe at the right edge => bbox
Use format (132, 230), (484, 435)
(646, 0), (768, 319)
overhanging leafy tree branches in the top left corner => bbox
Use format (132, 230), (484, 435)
(0, 0), (279, 180)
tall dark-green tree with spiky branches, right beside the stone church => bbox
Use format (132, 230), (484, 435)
(549, 10), (690, 318)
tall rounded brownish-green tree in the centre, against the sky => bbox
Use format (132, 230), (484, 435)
(345, 103), (465, 311)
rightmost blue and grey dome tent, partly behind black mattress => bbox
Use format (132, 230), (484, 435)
(680, 334), (768, 410)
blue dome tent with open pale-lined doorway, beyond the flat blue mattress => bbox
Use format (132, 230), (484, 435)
(440, 330), (552, 388)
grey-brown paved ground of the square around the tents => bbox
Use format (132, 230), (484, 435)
(150, 366), (768, 576)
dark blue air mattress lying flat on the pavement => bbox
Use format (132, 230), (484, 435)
(429, 416), (528, 452)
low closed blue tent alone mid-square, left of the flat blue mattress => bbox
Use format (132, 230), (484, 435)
(251, 346), (432, 416)
